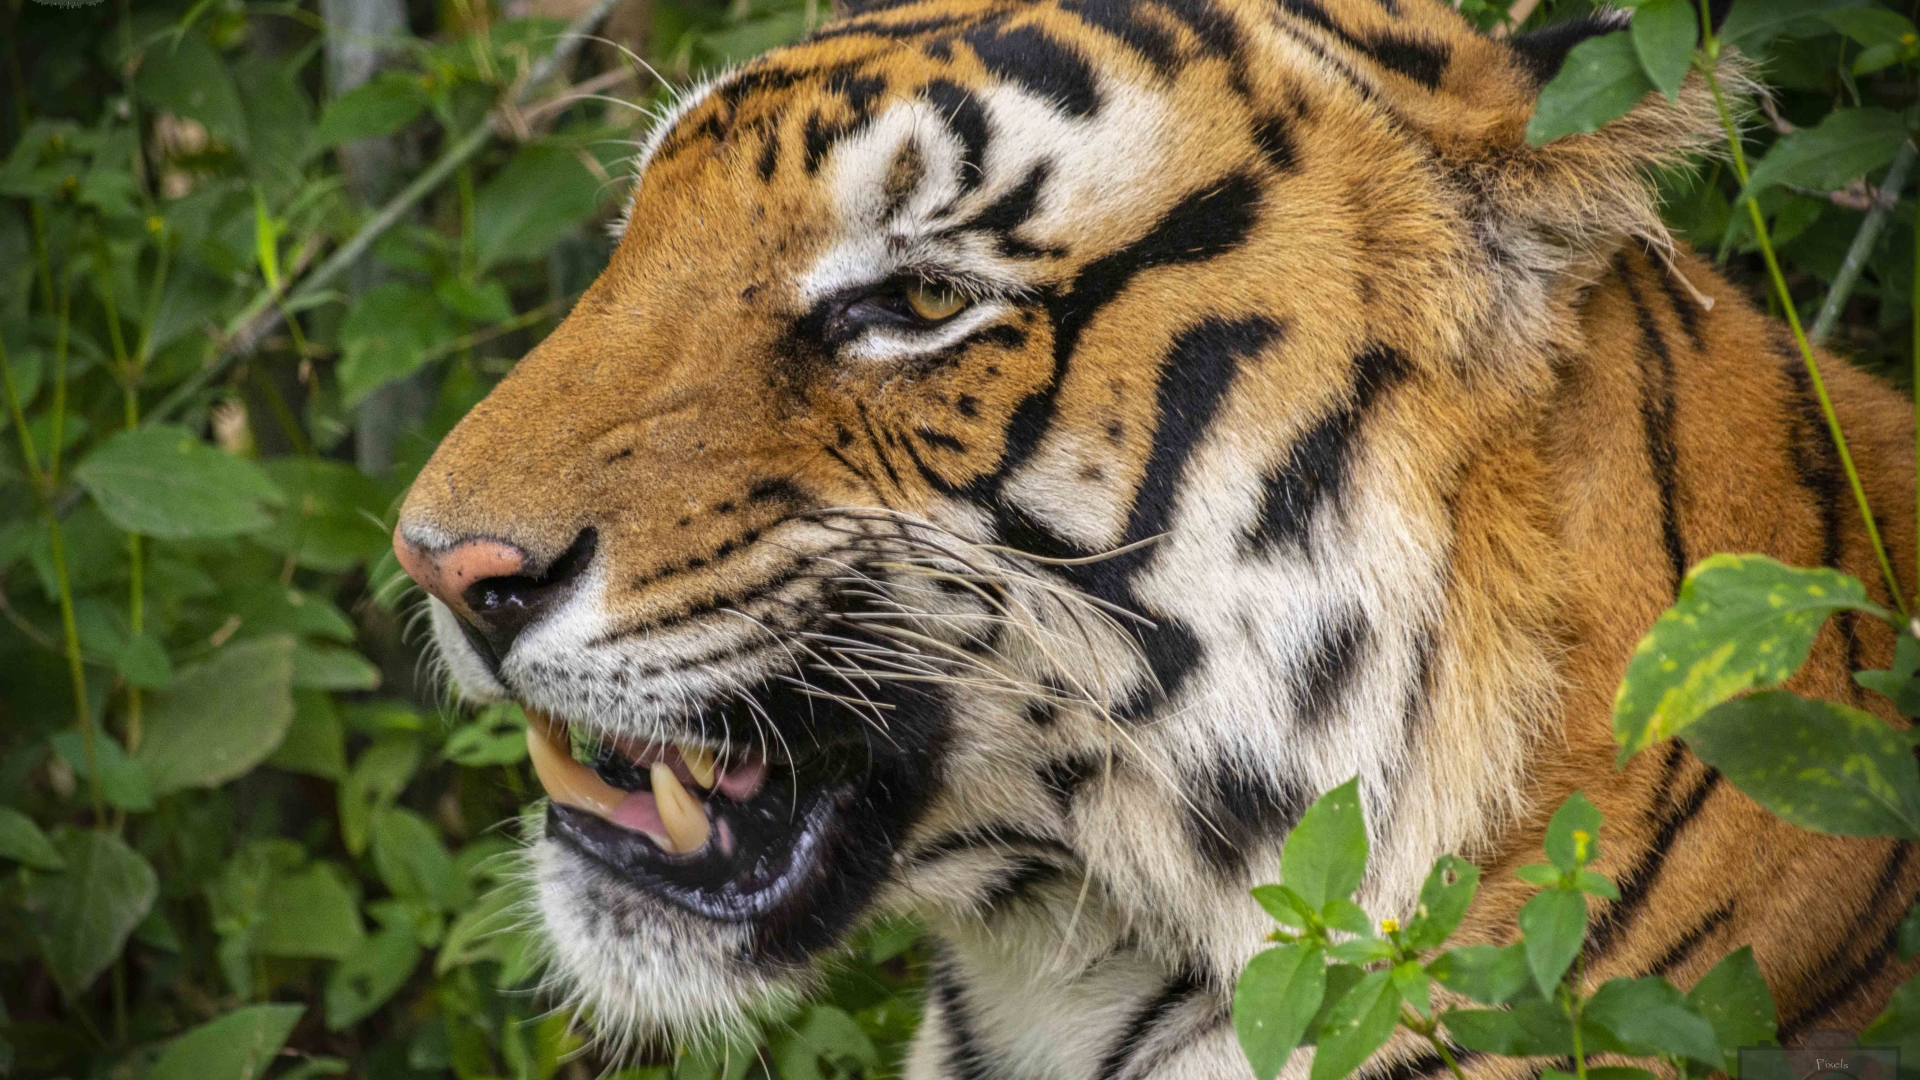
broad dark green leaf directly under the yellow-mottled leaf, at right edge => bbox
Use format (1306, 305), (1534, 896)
(1686, 690), (1920, 840)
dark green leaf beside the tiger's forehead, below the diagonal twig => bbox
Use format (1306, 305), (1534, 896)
(474, 144), (601, 269)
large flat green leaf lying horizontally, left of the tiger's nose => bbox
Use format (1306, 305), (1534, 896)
(73, 425), (282, 540)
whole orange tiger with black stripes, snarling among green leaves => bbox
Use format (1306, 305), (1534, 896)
(394, 0), (1920, 1080)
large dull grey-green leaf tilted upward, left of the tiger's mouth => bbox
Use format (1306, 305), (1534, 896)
(134, 638), (294, 796)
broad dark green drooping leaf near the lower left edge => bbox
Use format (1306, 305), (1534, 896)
(21, 826), (159, 1001)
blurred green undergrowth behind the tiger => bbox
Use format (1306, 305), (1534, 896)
(0, 0), (1916, 1080)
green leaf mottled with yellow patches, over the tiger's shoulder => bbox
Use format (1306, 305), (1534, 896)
(1613, 555), (1885, 759)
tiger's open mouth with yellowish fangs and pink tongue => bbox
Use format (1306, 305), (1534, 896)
(526, 691), (856, 920)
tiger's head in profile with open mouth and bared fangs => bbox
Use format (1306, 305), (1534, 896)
(396, 0), (1715, 1034)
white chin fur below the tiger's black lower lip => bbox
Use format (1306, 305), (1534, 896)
(532, 840), (804, 1043)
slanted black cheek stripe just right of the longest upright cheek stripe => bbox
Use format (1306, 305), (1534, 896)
(1240, 346), (1413, 552)
